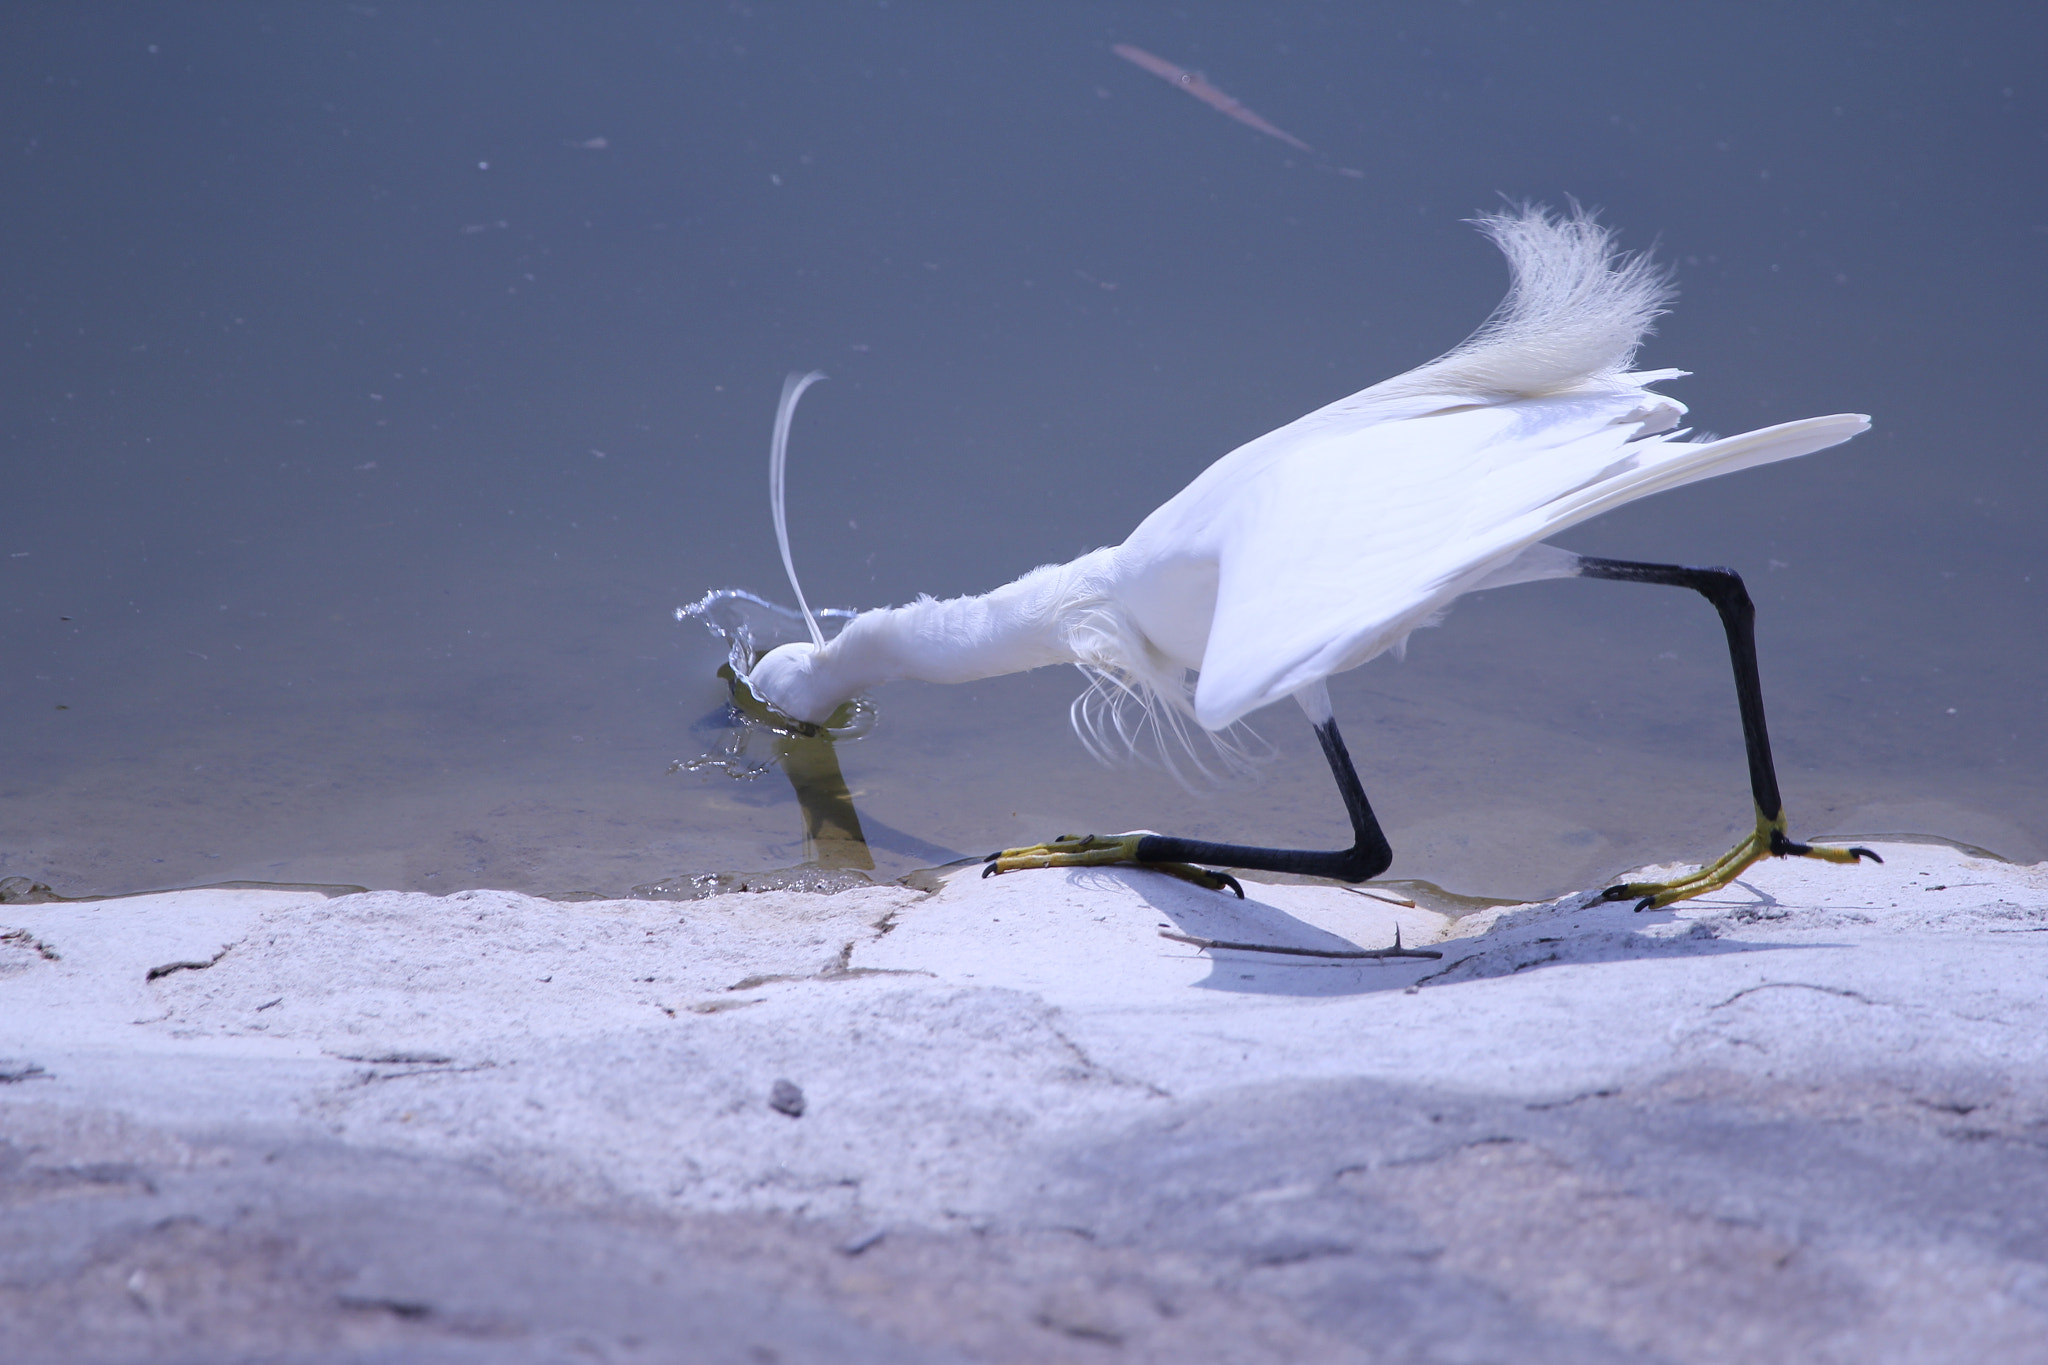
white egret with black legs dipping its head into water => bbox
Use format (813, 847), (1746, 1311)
(745, 207), (1876, 909)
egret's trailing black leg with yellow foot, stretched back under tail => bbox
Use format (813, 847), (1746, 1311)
(1579, 557), (1884, 911)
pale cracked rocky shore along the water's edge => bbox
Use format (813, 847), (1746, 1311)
(0, 843), (2048, 1363)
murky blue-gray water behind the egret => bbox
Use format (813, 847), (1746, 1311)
(0, 0), (2048, 894)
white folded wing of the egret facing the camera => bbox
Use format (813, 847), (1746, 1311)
(1196, 389), (1868, 729)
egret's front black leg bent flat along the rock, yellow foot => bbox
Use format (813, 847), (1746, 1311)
(981, 720), (1395, 896)
